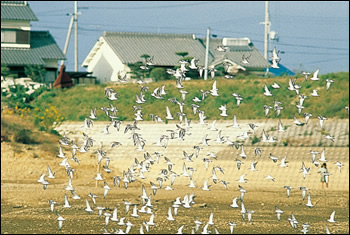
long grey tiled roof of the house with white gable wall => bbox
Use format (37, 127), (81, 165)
(102, 32), (269, 68)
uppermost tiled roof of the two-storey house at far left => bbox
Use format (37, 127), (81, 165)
(1, 1), (38, 21)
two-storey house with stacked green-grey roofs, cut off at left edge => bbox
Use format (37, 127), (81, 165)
(1, 1), (65, 84)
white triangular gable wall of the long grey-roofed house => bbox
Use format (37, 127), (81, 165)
(83, 37), (129, 83)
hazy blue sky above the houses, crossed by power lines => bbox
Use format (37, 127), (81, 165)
(28, 1), (349, 74)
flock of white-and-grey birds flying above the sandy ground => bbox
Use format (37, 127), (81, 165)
(37, 45), (349, 234)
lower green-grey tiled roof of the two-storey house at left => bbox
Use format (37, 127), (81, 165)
(1, 31), (65, 66)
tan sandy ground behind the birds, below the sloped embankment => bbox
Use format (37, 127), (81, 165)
(1, 121), (349, 234)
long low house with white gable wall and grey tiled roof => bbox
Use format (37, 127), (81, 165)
(82, 32), (270, 83)
